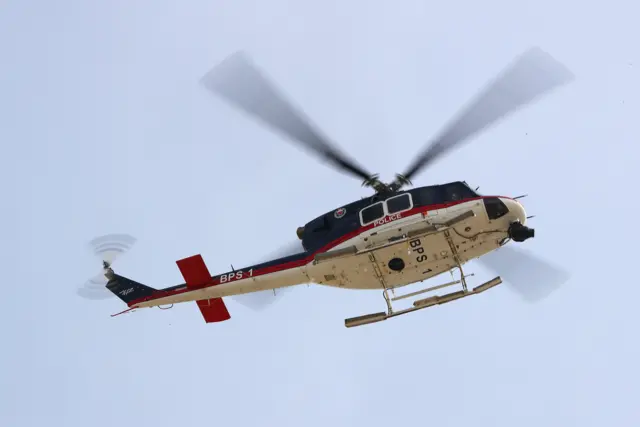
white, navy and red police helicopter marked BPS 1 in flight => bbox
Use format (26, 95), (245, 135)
(83, 47), (574, 327)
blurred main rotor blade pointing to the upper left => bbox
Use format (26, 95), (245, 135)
(201, 52), (372, 181)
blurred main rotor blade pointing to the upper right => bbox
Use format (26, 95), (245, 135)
(396, 48), (574, 185)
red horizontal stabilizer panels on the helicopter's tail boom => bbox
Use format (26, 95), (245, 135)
(176, 255), (231, 323)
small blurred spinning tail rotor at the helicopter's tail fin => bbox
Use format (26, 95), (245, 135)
(76, 234), (136, 300)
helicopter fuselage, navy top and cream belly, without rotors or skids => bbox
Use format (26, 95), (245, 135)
(129, 182), (526, 307)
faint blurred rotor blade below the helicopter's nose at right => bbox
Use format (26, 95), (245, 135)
(478, 246), (570, 302)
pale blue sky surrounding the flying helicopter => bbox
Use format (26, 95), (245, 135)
(0, 0), (640, 427)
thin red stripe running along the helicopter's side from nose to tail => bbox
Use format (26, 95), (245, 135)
(129, 196), (502, 307)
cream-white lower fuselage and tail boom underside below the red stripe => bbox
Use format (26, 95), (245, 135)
(136, 198), (526, 307)
